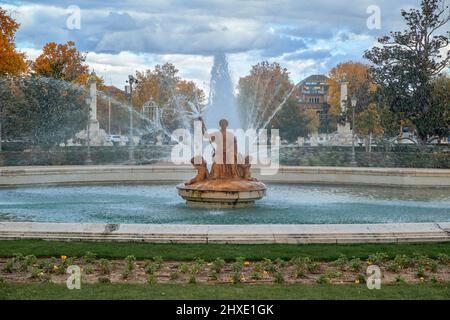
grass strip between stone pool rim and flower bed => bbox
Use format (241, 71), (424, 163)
(0, 240), (450, 261)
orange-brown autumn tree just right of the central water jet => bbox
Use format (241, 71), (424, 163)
(237, 61), (294, 128)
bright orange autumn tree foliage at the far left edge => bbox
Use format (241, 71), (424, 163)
(0, 7), (28, 76)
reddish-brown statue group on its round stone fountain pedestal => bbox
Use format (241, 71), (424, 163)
(177, 119), (266, 208)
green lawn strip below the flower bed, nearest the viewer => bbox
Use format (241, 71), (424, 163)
(0, 283), (450, 300)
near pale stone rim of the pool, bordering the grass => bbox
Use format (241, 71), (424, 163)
(0, 222), (450, 243)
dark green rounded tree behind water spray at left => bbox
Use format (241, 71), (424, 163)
(4, 77), (88, 149)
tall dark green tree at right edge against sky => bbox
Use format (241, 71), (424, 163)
(364, 0), (450, 142)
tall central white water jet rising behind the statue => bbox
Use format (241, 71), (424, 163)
(205, 53), (241, 129)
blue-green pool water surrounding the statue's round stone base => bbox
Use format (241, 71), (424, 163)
(0, 185), (450, 224)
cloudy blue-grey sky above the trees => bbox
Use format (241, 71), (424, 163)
(0, 0), (450, 90)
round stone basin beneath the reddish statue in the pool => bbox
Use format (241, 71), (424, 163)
(177, 180), (266, 209)
